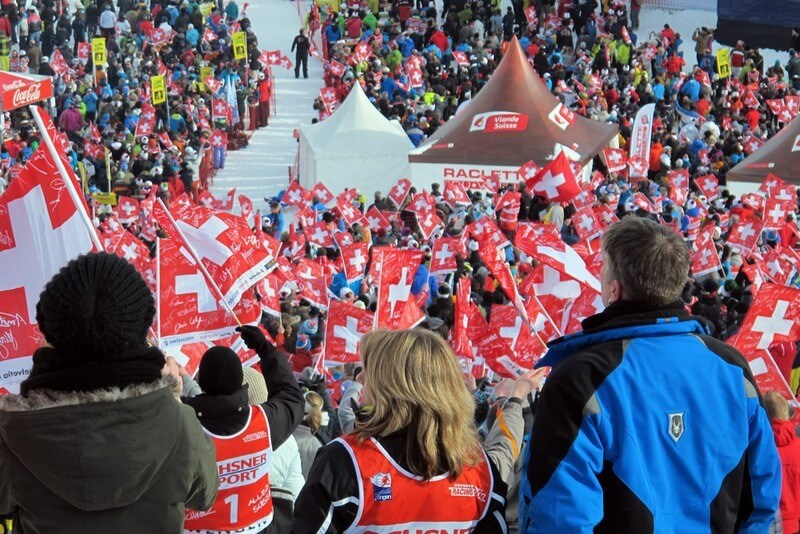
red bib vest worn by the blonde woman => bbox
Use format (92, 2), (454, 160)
(337, 436), (494, 534)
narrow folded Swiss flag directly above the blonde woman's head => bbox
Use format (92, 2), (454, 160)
(373, 247), (425, 330)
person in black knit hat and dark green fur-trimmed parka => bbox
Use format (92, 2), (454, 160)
(0, 253), (218, 534)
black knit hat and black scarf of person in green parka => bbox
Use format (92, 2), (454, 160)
(21, 252), (165, 394)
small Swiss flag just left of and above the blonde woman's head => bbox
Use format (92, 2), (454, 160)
(325, 300), (375, 363)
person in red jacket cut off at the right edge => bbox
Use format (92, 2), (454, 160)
(764, 391), (800, 534)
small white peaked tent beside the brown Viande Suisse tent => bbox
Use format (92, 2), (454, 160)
(298, 84), (414, 203)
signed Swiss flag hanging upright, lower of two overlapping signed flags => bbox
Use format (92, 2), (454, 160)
(156, 236), (261, 348)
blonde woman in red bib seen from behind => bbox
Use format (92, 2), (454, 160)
(293, 329), (506, 533)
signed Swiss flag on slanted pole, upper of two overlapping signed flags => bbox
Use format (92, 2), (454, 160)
(154, 201), (274, 306)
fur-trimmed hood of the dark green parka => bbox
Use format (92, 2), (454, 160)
(0, 377), (188, 511)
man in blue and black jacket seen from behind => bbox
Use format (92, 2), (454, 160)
(519, 216), (781, 534)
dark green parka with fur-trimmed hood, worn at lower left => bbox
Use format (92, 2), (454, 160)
(0, 379), (219, 534)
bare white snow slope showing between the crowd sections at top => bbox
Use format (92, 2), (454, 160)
(211, 0), (789, 209)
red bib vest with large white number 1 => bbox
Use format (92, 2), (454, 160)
(184, 406), (272, 534)
